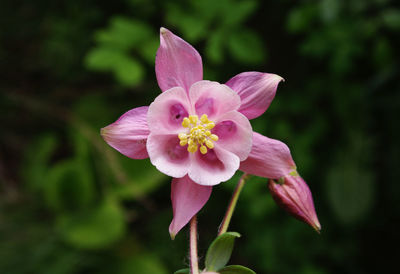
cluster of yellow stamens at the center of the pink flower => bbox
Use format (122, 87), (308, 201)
(178, 114), (218, 154)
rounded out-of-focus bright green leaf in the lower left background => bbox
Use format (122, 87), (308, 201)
(57, 200), (125, 249)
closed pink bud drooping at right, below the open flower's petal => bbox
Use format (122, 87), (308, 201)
(268, 171), (321, 233)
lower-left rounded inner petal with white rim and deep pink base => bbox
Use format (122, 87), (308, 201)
(147, 134), (190, 178)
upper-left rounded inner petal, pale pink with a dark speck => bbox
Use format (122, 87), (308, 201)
(147, 87), (191, 134)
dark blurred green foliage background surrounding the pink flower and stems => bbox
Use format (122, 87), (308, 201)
(0, 0), (400, 274)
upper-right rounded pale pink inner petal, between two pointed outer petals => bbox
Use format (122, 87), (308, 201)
(189, 80), (240, 120)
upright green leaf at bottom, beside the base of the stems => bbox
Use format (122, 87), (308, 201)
(206, 232), (240, 271)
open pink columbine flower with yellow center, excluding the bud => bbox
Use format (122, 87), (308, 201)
(101, 28), (320, 238)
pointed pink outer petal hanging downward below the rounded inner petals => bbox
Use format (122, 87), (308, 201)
(169, 176), (212, 239)
